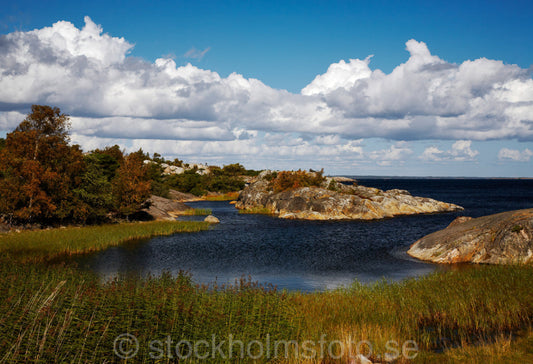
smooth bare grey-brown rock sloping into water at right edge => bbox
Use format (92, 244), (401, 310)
(407, 209), (533, 264)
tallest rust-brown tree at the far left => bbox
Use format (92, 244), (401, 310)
(0, 105), (84, 222)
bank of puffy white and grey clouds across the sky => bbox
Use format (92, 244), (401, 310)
(0, 17), (533, 171)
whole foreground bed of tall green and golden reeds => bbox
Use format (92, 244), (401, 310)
(0, 262), (533, 363)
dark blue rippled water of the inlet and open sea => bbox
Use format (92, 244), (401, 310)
(74, 178), (533, 291)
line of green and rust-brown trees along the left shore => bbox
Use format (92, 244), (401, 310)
(0, 105), (256, 225)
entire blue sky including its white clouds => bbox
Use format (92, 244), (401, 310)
(0, 0), (533, 177)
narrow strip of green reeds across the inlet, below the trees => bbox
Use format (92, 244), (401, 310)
(0, 221), (209, 262)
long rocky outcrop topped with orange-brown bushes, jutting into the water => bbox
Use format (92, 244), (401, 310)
(235, 171), (463, 220)
